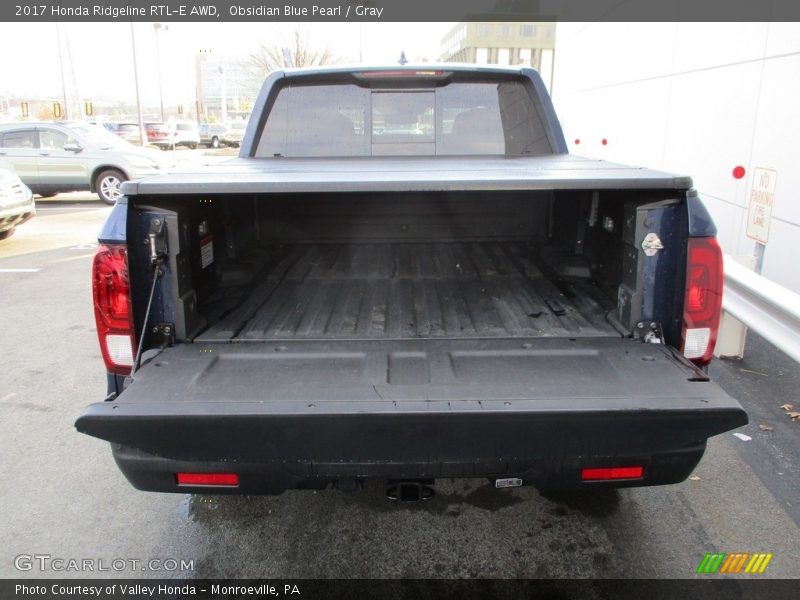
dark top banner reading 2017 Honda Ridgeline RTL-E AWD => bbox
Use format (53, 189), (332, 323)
(0, 0), (800, 23)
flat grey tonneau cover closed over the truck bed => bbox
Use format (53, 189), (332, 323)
(122, 154), (692, 196)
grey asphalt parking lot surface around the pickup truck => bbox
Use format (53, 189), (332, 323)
(0, 194), (800, 578)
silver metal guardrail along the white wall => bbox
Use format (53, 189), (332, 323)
(722, 254), (800, 362)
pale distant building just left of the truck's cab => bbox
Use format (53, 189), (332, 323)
(195, 50), (263, 123)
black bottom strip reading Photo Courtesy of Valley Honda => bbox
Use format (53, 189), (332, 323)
(0, 576), (797, 600)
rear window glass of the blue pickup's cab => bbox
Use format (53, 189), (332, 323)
(256, 80), (553, 157)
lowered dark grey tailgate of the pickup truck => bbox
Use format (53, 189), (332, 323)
(76, 338), (747, 469)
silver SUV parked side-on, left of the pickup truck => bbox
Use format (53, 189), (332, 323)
(0, 122), (169, 204)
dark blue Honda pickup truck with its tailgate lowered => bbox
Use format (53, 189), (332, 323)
(76, 64), (747, 500)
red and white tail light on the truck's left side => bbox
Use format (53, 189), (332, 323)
(92, 244), (136, 375)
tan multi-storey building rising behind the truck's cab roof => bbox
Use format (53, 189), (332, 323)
(440, 23), (556, 88)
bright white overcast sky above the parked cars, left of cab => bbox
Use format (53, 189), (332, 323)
(0, 23), (454, 104)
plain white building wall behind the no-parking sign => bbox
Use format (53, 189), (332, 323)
(552, 23), (800, 292)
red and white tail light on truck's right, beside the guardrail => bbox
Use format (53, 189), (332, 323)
(681, 237), (723, 366)
